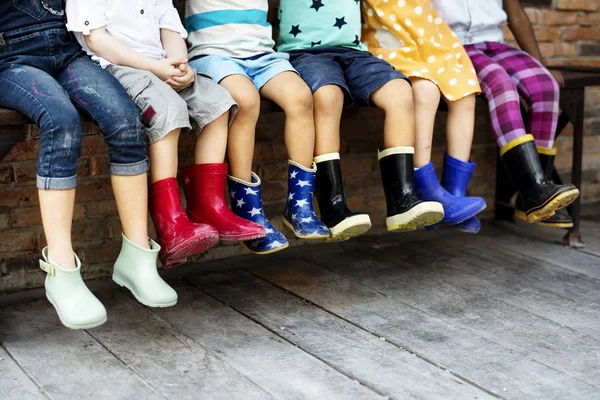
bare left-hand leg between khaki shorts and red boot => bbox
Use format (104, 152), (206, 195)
(148, 129), (181, 183)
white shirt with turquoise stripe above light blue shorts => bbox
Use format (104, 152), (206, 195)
(185, 0), (275, 58)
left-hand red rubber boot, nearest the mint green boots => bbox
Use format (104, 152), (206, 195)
(149, 178), (219, 268)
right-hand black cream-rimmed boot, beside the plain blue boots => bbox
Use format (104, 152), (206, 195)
(378, 146), (444, 232)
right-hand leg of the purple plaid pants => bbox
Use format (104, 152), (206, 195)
(488, 43), (560, 149)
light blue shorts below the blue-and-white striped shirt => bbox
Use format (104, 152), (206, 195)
(190, 53), (296, 90)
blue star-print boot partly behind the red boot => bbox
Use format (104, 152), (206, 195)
(229, 172), (289, 254)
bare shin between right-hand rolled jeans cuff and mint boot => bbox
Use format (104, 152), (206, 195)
(110, 174), (149, 249)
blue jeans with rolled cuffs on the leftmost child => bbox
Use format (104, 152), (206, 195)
(0, 22), (148, 190)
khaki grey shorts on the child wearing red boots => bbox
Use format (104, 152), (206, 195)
(107, 65), (238, 143)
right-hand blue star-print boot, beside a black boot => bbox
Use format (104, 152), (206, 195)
(283, 160), (331, 239)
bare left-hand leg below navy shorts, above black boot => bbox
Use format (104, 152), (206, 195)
(313, 85), (344, 156)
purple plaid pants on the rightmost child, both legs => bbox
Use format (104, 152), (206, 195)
(465, 42), (559, 148)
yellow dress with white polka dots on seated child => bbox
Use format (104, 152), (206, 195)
(362, 0), (481, 101)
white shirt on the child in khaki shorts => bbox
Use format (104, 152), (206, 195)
(66, 0), (187, 68)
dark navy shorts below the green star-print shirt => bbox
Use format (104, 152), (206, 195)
(289, 47), (408, 106)
